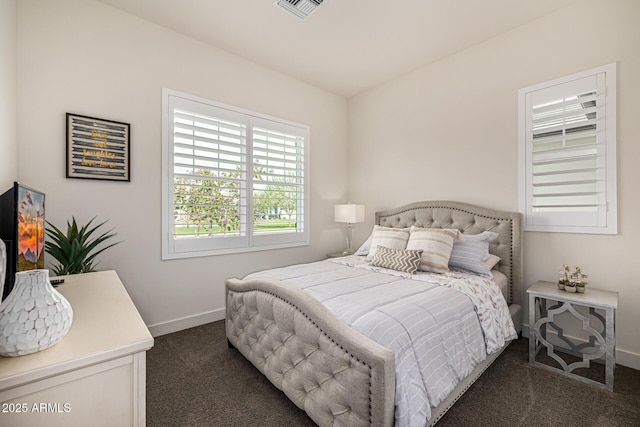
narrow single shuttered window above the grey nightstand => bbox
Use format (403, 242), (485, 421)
(519, 63), (617, 234)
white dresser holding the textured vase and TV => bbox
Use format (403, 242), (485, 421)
(0, 271), (153, 427)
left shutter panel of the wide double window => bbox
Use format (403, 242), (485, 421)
(172, 94), (248, 252)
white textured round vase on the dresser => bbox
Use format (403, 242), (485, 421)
(0, 270), (73, 356)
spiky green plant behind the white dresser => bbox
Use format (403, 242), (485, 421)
(44, 217), (122, 276)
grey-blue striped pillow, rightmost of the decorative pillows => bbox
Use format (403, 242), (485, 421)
(449, 231), (498, 277)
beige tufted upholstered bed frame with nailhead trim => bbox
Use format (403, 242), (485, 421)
(226, 201), (522, 426)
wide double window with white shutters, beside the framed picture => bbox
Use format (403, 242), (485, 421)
(162, 89), (309, 259)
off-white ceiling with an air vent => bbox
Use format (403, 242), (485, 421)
(100, 0), (582, 97)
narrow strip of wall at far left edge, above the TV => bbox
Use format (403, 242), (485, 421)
(0, 0), (18, 189)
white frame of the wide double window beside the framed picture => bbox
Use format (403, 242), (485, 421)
(161, 88), (310, 260)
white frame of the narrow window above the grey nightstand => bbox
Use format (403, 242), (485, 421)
(518, 63), (618, 234)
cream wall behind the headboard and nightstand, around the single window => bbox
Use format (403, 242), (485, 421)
(349, 0), (640, 369)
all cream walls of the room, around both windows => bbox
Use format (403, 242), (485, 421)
(13, 0), (640, 368)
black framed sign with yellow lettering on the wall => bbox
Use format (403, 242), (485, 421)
(67, 113), (131, 181)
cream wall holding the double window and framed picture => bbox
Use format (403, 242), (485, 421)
(18, 0), (347, 334)
